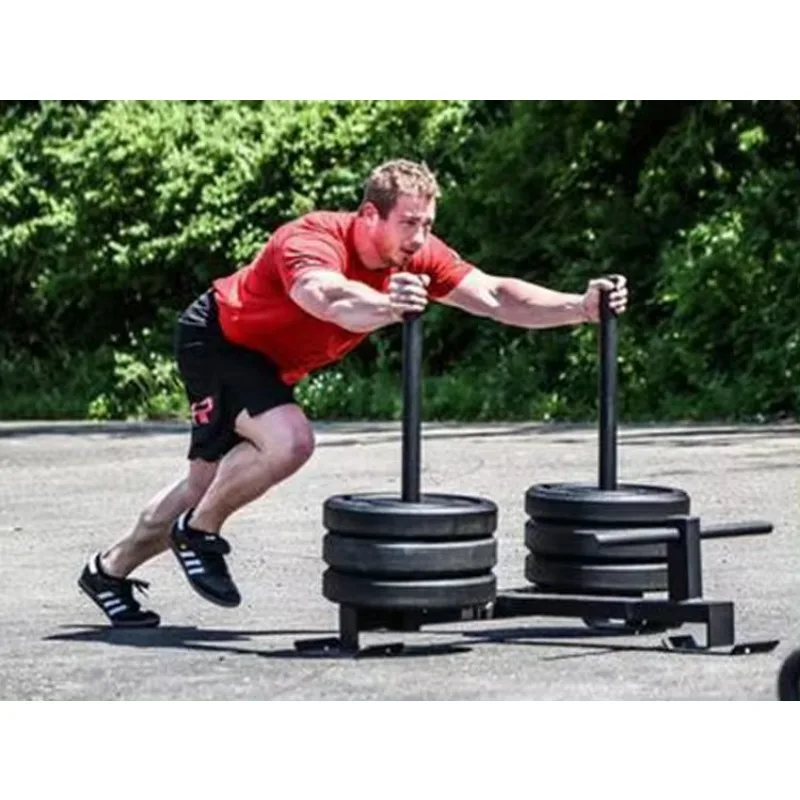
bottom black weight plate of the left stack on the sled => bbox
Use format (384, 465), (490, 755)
(322, 569), (497, 609)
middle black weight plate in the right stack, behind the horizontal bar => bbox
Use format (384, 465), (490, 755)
(525, 520), (667, 563)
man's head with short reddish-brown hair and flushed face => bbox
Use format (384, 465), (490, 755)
(359, 159), (440, 268)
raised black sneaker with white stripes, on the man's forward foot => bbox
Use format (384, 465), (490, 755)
(170, 511), (242, 608)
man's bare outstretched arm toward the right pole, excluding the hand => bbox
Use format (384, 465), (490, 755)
(440, 268), (590, 328)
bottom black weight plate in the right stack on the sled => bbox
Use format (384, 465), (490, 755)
(525, 555), (667, 594)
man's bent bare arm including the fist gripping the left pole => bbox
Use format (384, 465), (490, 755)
(289, 269), (427, 333)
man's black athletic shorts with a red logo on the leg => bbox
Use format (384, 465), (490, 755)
(175, 291), (295, 461)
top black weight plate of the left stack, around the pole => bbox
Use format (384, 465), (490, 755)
(322, 492), (497, 539)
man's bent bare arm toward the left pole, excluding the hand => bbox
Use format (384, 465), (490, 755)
(289, 269), (402, 333)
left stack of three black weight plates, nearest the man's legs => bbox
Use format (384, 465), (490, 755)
(322, 493), (497, 610)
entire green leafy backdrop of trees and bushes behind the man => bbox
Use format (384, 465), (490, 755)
(0, 101), (800, 420)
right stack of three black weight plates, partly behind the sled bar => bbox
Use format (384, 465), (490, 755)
(525, 483), (690, 596)
